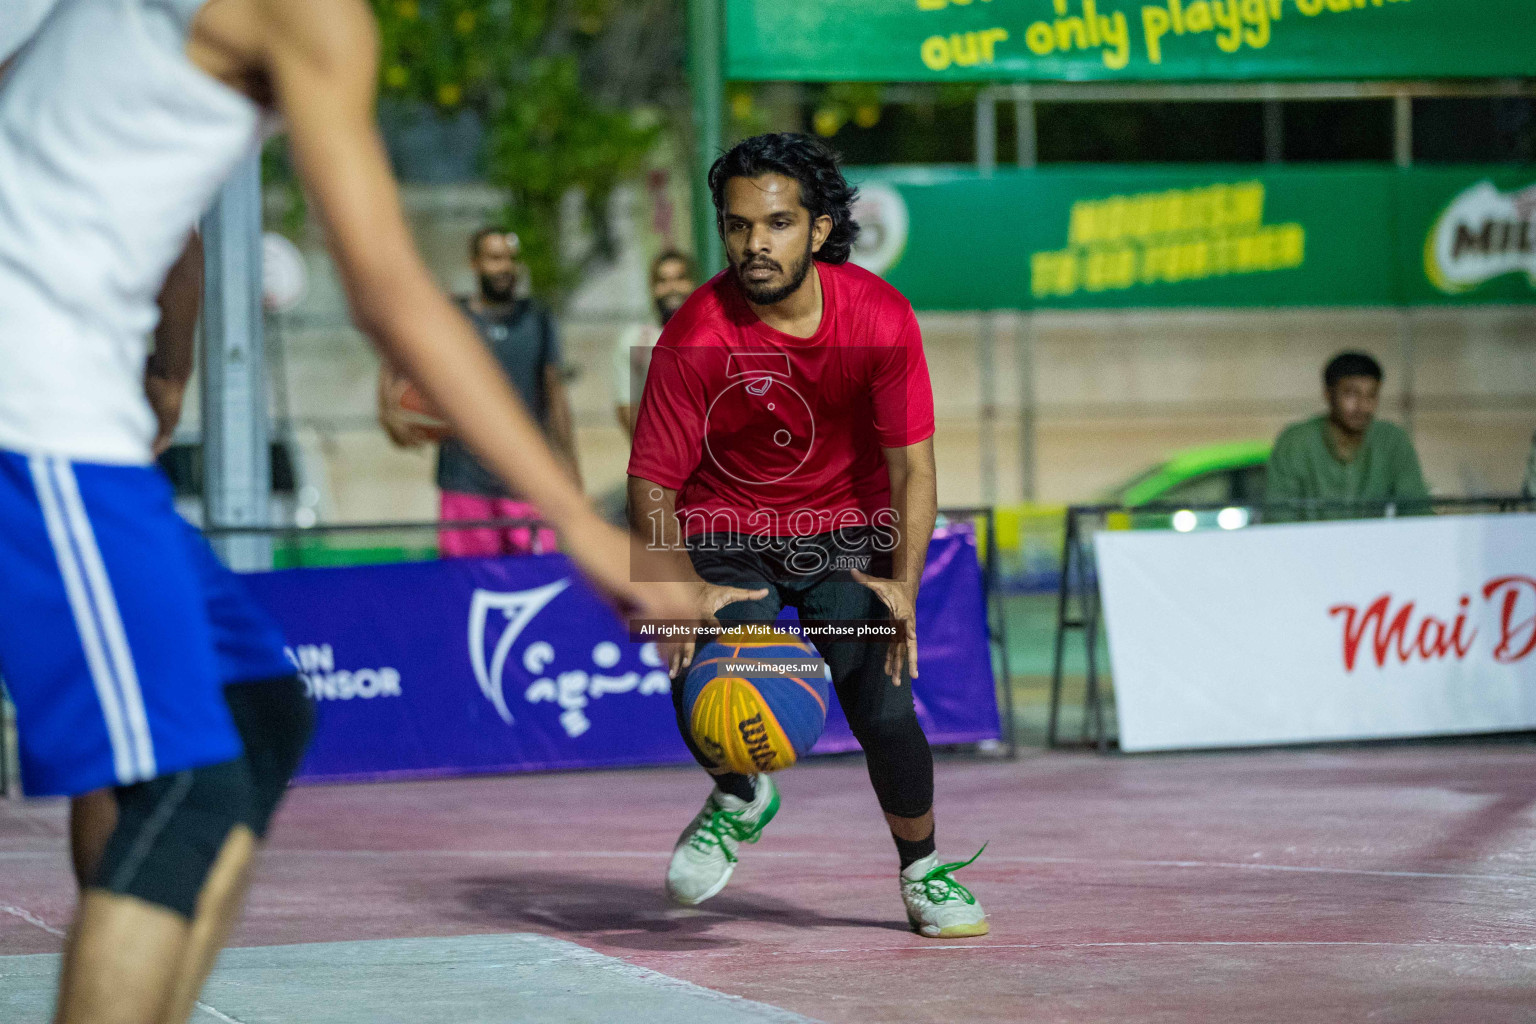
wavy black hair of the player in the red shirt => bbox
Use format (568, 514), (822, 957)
(710, 132), (859, 264)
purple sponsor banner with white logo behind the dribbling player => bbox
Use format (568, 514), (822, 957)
(246, 525), (1001, 781)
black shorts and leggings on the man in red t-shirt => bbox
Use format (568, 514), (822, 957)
(673, 531), (934, 818)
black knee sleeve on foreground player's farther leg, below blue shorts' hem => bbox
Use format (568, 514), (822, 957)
(224, 676), (315, 838)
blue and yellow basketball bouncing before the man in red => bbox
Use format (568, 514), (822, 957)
(682, 631), (828, 775)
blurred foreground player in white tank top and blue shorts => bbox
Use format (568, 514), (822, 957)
(0, 0), (697, 1024)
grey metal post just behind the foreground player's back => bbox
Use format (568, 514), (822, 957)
(201, 154), (272, 571)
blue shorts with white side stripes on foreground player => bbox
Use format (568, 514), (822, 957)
(0, 451), (293, 795)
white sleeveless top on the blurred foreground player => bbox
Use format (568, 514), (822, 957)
(0, 0), (261, 465)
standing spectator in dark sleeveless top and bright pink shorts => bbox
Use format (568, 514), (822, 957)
(381, 227), (581, 559)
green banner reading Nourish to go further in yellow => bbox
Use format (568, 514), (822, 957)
(849, 166), (1536, 310)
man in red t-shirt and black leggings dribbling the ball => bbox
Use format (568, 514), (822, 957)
(630, 135), (988, 938)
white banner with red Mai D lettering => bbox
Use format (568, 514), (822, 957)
(1095, 516), (1536, 751)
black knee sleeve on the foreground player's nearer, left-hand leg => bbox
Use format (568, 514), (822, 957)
(95, 760), (250, 920)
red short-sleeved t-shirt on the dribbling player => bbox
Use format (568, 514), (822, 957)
(630, 263), (934, 537)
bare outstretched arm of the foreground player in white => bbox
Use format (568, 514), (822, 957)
(260, 0), (682, 616)
